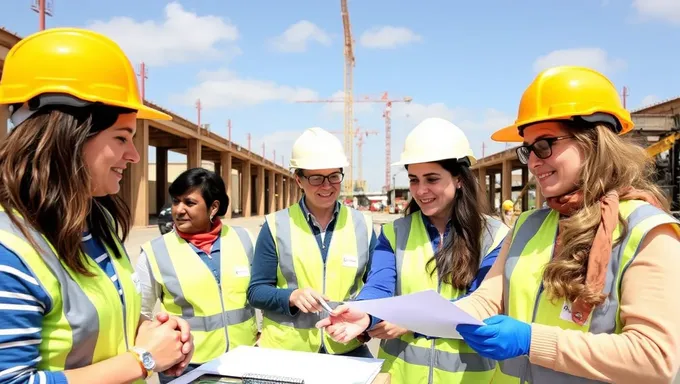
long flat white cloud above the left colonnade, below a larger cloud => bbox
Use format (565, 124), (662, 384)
(171, 69), (318, 108)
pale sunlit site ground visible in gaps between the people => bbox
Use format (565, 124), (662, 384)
(125, 212), (400, 384)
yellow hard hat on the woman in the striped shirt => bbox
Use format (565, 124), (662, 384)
(0, 28), (172, 120)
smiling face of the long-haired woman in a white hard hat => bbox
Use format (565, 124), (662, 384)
(408, 163), (460, 220)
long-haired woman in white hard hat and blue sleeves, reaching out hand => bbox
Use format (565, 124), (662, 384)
(318, 118), (509, 384)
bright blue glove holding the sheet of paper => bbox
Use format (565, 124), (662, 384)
(456, 315), (531, 361)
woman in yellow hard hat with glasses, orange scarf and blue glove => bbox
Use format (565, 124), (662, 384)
(446, 66), (680, 384)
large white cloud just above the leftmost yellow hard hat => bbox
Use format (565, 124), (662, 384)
(88, 2), (240, 66)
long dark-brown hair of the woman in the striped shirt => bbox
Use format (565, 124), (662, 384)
(0, 104), (134, 275)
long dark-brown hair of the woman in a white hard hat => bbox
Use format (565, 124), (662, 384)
(405, 159), (488, 289)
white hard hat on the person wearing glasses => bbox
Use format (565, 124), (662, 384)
(290, 127), (349, 169)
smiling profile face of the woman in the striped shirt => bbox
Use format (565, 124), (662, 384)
(83, 113), (139, 196)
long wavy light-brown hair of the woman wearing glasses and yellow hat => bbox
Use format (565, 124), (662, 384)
(543, 124), (668, 306)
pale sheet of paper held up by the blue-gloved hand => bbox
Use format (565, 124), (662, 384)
(346, 290), (484, 339)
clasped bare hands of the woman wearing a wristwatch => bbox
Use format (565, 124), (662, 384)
(135, 313), (193, 372)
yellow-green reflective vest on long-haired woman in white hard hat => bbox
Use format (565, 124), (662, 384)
(378, 212), (509, 384)
